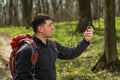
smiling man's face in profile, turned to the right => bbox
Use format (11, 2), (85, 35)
(42, 20), (54, 38)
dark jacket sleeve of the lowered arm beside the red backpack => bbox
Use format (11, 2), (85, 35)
(14, 44), (32, 80)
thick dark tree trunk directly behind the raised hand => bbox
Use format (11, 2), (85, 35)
(76, 0), (92, 33)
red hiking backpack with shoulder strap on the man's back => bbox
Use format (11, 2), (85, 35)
(9, 34), (38, 78)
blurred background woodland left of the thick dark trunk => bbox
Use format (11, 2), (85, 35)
(0, 0), (92, 26)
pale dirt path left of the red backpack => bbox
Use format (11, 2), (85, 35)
(0, 34), (11, 80)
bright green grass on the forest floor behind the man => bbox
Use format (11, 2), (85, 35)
(0, 18), (120, 80)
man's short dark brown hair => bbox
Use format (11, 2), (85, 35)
(32, 13), (51, 33)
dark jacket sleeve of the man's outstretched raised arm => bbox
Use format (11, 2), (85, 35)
(56, 39), (90, 60)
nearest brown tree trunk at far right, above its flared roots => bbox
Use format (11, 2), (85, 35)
(104, 0), (118, 64)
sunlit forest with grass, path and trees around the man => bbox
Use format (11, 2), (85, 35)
(0, 0), (120, 80)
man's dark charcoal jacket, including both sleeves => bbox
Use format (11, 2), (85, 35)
(15, 36), (89, 80)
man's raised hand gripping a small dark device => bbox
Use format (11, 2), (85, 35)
(84, 26), (93, 42)
